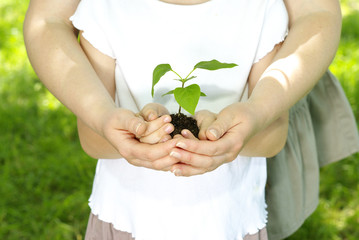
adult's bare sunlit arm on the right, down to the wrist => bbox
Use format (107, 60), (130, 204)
(214, 0), (342, 136)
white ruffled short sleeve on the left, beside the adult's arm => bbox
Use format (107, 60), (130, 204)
(70, 0), (115, 58)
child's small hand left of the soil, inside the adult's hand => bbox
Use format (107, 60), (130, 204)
(136, 103), (174, 144)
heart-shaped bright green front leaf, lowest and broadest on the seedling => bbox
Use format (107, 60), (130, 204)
(174, 84), (201, 115)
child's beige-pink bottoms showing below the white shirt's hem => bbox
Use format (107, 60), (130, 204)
(85, 213), (268, 240)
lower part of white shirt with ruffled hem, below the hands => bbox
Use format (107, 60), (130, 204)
(89, 158), (267, 240)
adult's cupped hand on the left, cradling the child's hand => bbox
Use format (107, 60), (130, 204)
(102, 108), (179, 171)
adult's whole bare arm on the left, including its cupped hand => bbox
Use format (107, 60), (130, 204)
(24, 0), (178, 168)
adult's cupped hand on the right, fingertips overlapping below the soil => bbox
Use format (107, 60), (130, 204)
(170, 103), (259, 176)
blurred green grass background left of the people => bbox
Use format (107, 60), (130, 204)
(0, 0), (96, 240)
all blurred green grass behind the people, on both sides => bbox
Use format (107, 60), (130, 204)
(0, 0), (359, 240)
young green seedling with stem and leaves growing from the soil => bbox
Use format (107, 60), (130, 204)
(151, 60), (237, 115)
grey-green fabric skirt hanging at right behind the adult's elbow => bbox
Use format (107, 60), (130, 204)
(266, 72), (359, 240)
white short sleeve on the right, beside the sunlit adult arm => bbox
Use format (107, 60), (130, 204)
(254, 0), (288, 62)
